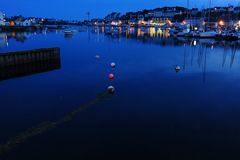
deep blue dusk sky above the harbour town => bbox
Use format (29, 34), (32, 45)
(0, 0), (239, 20)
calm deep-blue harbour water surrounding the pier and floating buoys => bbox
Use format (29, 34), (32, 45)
(0, 28), (240, 160)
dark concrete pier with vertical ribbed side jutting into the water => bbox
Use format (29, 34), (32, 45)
(0, 48), (61, 80)
